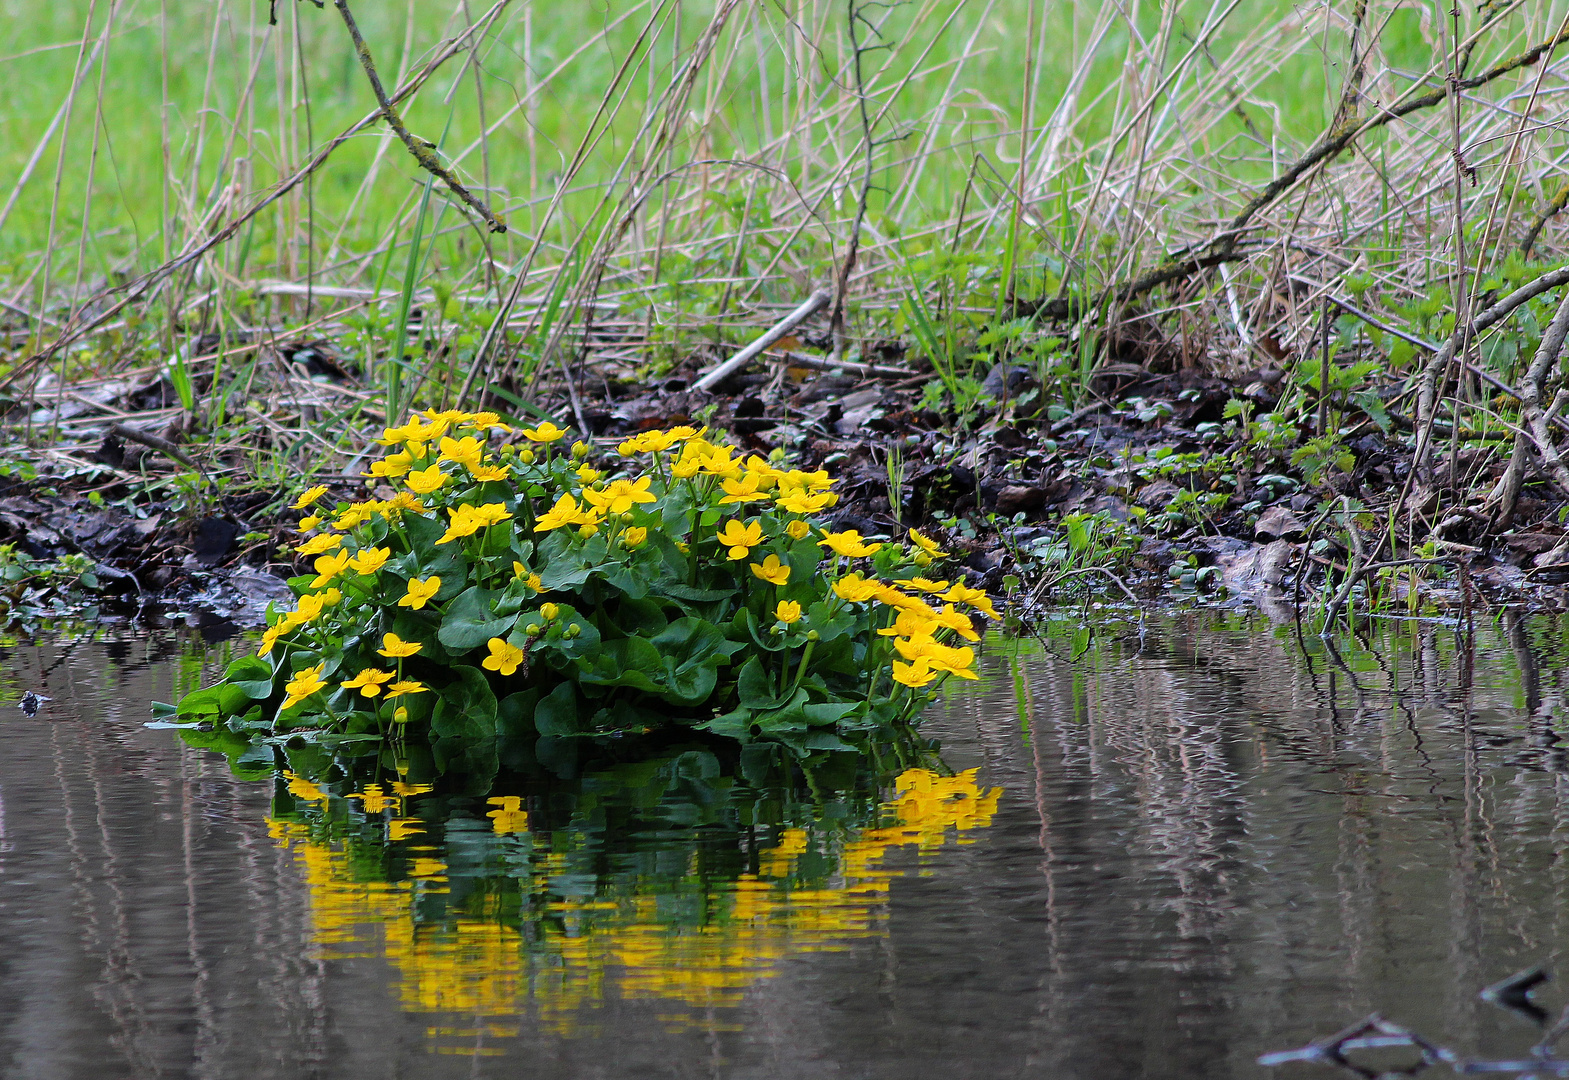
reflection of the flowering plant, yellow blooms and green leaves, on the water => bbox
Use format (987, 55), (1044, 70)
(270, 755), (1001, 1055)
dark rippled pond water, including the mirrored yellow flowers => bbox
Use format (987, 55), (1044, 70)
(0, 615), (1569, 1080)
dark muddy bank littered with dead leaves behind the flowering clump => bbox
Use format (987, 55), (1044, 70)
(0, 342), (1569, 626)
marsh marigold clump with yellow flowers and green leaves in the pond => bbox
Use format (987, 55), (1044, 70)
(162, 411), (996, 753)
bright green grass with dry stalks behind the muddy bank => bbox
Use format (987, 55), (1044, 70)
(0, 0), (1569, 452)
